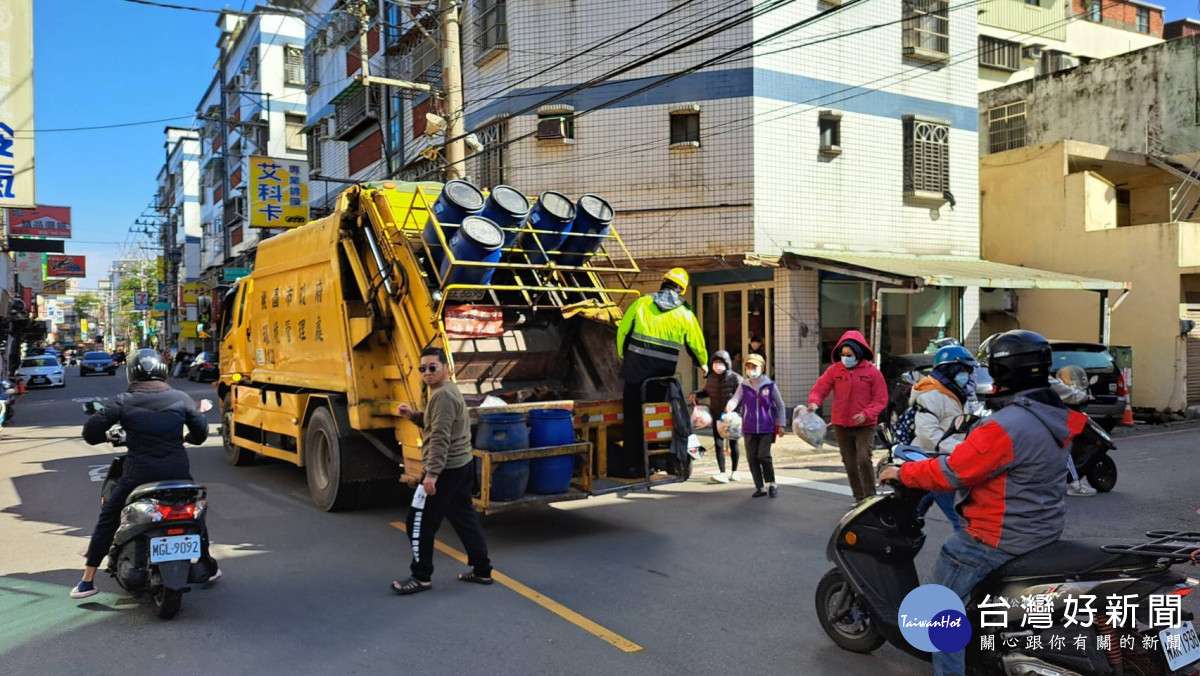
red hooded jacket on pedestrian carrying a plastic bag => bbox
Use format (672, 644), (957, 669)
(809, 331), (888, 427)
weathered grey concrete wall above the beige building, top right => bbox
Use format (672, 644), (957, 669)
(979, 37), (1200, 152)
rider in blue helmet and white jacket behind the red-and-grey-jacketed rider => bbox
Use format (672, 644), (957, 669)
(908, 345), (976, 530)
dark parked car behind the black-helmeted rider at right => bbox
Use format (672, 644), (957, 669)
(976, 337), (1129, 431)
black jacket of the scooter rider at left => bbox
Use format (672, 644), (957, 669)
(83, 381), (209, 481)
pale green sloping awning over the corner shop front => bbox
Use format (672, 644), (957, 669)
(782, 249), (1133, 292)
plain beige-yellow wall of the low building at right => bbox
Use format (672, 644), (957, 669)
(980, 144), (1195, 408)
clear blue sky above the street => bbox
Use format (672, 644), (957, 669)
(25, 0), (1200, 288)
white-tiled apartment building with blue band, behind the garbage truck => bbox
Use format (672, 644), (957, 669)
(306, 0), (1123, 401)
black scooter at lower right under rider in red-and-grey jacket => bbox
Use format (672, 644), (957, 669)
(816, 445), (1200, 676)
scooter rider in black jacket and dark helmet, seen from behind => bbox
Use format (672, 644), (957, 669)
(71, 349), (221, 599)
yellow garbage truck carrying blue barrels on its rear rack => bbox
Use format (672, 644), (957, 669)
(216, 181), (691, 513)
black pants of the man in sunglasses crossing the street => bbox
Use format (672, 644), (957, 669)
(408, 462), (492, 582)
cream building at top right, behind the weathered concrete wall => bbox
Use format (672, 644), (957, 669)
(978, 0), (1164, 91)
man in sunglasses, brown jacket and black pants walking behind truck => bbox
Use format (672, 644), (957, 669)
(391, 347), (493, 596)
